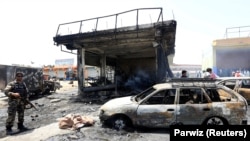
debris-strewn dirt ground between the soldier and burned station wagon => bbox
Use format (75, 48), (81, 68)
(0, 81), (169, 141)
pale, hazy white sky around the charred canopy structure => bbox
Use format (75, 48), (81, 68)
(0, 0), (250, 65)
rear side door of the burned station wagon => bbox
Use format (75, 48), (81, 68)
(176, 88), (212, 125)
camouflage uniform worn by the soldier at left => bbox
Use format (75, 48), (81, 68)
(4, 80), (28, 130)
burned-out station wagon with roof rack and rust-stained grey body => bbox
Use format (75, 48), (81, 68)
(99, 78), (248, 130)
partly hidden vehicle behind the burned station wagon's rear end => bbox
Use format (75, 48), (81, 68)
(217, 77), (250, 105)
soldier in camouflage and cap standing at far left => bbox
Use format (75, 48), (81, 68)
(4, 72), (28, 135)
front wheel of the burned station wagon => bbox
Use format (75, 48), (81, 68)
(112, 116), (131, 130)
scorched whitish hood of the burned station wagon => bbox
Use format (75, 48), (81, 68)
(103, 96), (134, 107)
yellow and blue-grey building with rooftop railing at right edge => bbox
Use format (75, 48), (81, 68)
(202, 26), (250, 77)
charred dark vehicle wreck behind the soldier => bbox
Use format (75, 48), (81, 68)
(0, 65), (62, 96)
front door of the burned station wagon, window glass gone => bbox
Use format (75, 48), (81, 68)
(135, 89), (176, 128)
